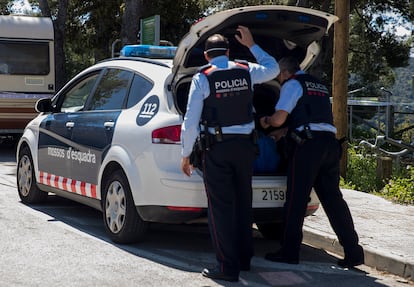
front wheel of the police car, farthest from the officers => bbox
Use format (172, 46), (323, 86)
(16, 146), (48, 204)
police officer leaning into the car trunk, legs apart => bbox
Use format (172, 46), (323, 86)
(260, 57), (364, 267)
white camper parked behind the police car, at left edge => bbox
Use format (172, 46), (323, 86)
(0, 15), (55, 139)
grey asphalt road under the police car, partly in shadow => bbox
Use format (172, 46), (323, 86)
(0, 142), (412, 287)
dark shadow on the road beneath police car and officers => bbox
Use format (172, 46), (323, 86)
(19, 196), (385, 287)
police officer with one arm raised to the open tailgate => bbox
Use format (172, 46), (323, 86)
(181, 26), (279, 281)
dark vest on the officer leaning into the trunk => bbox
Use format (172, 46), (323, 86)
(288, 74), (333, 129)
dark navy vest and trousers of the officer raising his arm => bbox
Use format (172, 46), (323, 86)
(201, 64), (255, 276)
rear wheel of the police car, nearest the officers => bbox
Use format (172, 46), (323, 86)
(102, 170), (148, 244)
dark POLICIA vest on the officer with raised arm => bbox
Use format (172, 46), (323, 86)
(201, 63), (253, 127)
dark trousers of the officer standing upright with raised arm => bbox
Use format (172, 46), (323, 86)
(204, 137), (255, 276)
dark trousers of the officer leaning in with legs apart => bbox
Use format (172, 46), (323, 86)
(282, 132), (358, 259)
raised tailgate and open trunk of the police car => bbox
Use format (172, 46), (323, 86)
(172, 5), (338, 174)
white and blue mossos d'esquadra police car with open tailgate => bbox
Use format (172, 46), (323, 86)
(17, 5), (337, 243)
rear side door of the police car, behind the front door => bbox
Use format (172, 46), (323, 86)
(68, 68), (133, 198)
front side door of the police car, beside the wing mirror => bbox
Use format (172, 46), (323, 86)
(38, 71), (100, 187)
